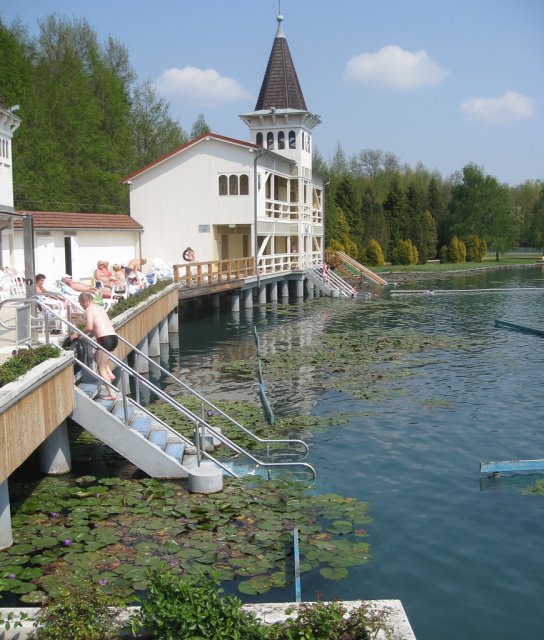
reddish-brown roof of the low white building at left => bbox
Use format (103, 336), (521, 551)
(13, 211), (143, 231)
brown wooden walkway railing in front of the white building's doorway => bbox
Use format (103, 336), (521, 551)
(174, 257), (256, 288)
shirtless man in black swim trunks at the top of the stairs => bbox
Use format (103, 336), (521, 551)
(70, 292), (118, 400)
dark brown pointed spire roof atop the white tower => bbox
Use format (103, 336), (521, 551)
(255, 15), (308, 111)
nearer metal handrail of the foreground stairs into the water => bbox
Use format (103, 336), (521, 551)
(19, 300), (316, 478)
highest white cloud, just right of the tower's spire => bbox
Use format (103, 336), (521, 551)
(346, 45), (448, 91)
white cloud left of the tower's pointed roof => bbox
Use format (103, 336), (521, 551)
(156, 67), (249, 106)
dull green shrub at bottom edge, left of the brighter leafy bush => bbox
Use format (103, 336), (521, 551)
(32, 581), (120, 640)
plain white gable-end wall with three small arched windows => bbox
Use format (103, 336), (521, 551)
(130, 139), (262, 263)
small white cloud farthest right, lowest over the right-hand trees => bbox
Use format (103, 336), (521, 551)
(461, 91), (535, 124)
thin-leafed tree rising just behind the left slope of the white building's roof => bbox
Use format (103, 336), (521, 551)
(132, 80), (187, 167)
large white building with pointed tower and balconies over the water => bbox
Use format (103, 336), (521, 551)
(124, 16), (325, 274)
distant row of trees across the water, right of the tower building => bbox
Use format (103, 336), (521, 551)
(314, 145), (544, 263)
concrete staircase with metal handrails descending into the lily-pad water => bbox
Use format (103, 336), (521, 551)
(49, 310), (316, 480)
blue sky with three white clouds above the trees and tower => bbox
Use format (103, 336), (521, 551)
(0, 0), (544, 185)
